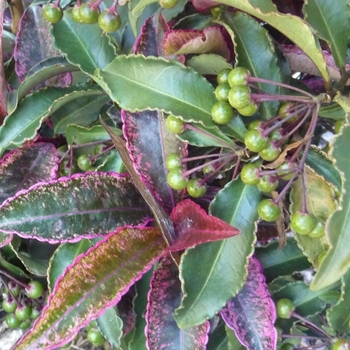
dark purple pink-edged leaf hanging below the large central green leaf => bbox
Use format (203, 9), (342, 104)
(122, 111), (186, 213)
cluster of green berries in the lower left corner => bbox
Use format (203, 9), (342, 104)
(1, 280), (44, 330)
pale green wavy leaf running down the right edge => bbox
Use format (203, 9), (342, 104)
(310, 124), (350, 290)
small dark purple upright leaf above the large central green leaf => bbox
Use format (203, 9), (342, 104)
(134, 12), (170, 57)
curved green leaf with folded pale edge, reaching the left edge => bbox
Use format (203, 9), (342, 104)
(0, 84), (103, 154)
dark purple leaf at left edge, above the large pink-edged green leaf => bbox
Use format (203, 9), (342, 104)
(0, 142), (58, 203)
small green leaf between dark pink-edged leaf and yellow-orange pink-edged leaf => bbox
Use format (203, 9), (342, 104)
(47, 239), (93, 293)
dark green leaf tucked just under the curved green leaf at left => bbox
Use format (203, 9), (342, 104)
(51, 94), (109, 134)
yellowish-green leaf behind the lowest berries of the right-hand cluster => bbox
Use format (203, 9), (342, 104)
(290, 166), (336, 264)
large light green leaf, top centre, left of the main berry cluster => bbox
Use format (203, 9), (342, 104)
(95, 55), (216, 128)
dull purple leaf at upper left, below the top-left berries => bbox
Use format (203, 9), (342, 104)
(14, 6), (72, 87)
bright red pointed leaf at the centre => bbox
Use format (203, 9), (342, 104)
(168, 199), (240, 251)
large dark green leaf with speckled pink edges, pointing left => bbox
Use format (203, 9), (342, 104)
(0, 173), (150, 243)
